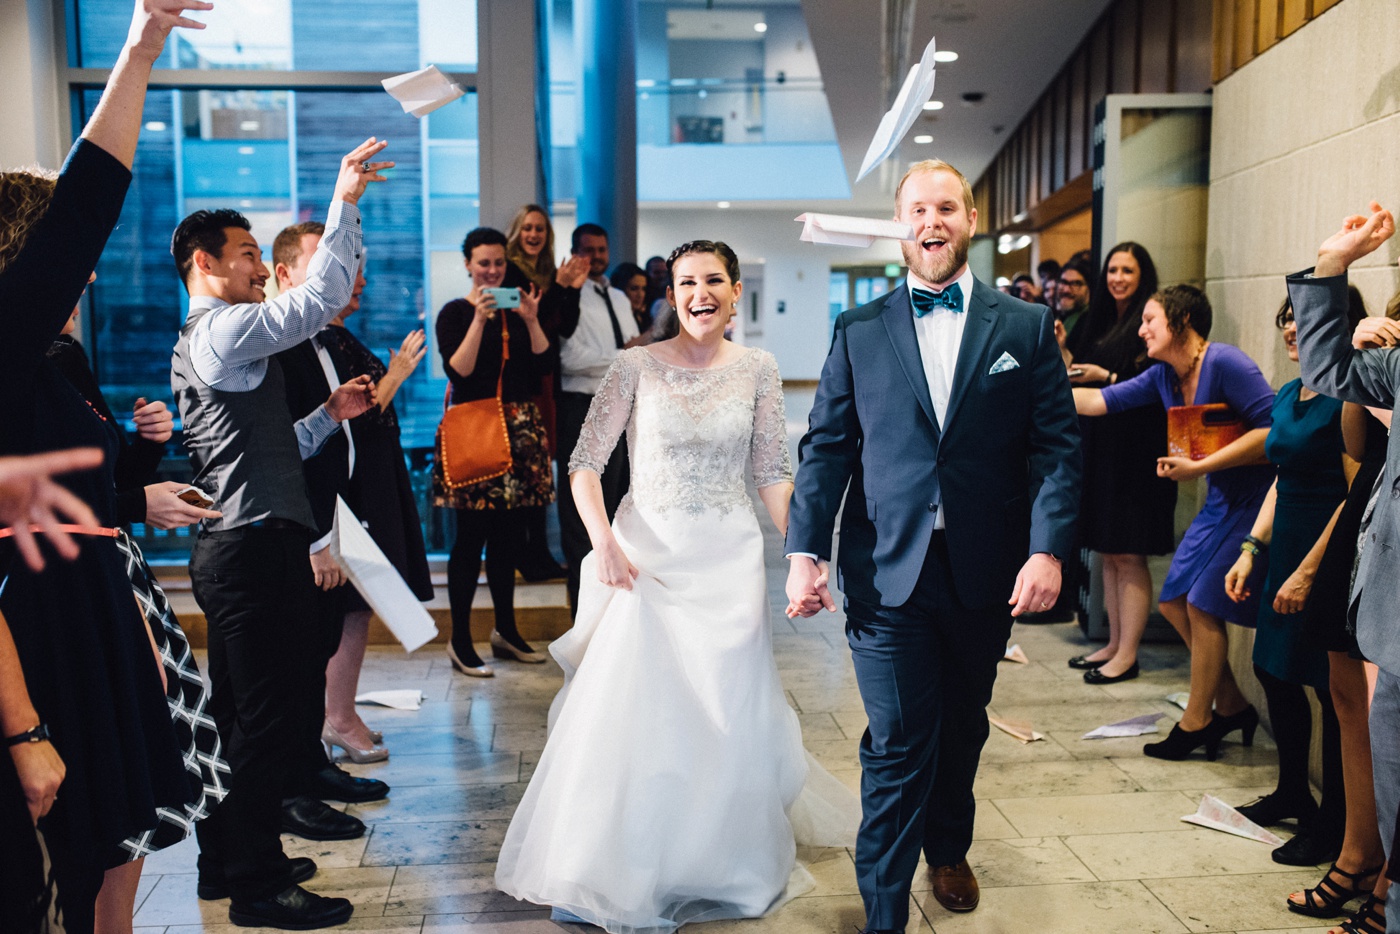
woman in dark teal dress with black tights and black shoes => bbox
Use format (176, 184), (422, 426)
(1225, 295), (1373, 881)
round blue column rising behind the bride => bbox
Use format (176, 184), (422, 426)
(574, 0), (637, 262)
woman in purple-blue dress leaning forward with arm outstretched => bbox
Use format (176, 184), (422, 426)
(1074, 286), (1274, 759)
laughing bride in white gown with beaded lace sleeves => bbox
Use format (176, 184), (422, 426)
(496, 241), (860, 934)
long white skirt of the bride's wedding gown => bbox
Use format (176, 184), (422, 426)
(496, 504), (860, 934)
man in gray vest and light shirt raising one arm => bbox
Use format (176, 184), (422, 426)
(171, 139), (393, 930)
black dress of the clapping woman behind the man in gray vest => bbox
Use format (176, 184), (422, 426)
(318, 325), (433, 611)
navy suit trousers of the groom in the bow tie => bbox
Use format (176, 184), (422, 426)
(846, 532), (1011, 931)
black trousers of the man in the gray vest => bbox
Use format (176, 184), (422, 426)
(189, 527), (326, 900)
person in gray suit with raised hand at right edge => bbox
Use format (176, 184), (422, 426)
(1288, 202), (1400, 934)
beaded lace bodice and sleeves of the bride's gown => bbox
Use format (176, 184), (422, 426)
(568, 347), (792, 515)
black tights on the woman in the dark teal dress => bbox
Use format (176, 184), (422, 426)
(1254, 665), (1347, 843)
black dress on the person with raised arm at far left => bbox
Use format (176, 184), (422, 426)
(0, 140), (197, 930)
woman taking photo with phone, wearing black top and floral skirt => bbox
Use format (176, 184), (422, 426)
(433, 227), (557, 678)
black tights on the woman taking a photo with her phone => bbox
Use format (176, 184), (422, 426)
(447, 510), (525, 665)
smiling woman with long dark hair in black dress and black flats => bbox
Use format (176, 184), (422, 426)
(1063, 242), (1176, 685)
